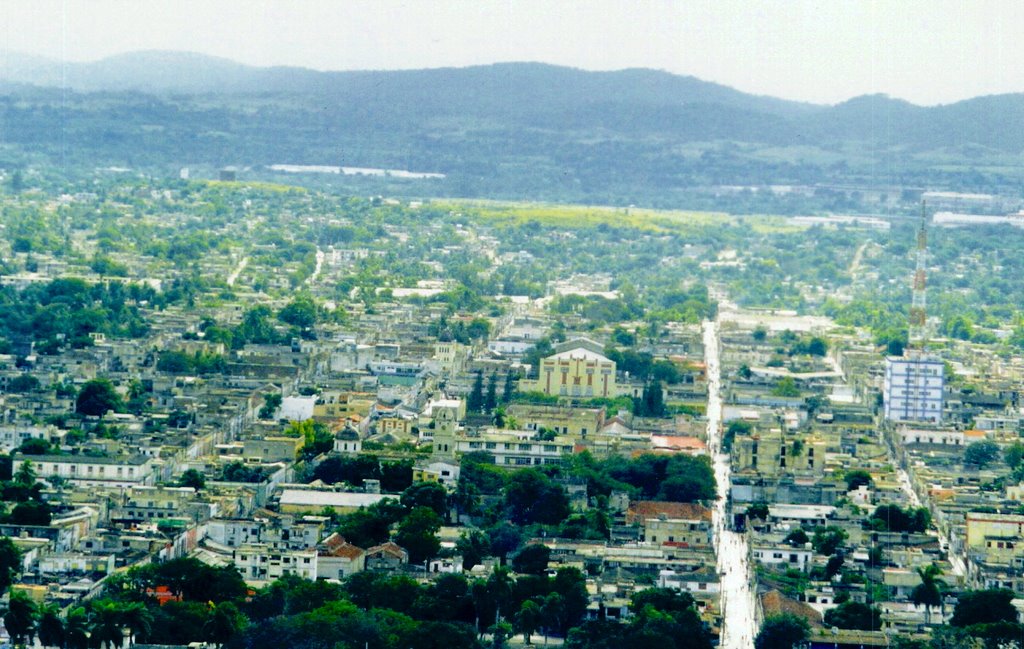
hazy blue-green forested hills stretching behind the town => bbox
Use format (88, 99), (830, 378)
(0, 52), (1024, 205)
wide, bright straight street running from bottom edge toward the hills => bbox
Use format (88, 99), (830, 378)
(703, 320), (757, 649)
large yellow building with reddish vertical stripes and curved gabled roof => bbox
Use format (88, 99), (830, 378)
(524, 347), (618, 398)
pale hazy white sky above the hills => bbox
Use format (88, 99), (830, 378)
(0, 0), (1024, 104)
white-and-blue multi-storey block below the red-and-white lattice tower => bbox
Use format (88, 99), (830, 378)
(884, 356), (945, 424)
